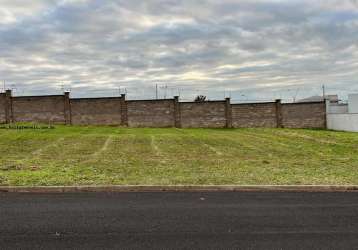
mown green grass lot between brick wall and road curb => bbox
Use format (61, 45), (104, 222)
(0, 126), (358, 185)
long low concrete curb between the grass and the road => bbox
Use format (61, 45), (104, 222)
(0, 185), (358, 193)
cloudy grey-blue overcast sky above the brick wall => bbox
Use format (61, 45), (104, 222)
(0, 0), (358, 101)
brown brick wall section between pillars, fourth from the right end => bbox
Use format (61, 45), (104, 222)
(126, 100), (175, 127)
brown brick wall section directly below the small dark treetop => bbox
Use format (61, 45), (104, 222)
(179, 101), (226, 128)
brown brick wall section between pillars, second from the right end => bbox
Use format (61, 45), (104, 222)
(231, 103), (277, 128)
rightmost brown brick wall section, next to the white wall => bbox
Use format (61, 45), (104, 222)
(281, 102), (326, 128)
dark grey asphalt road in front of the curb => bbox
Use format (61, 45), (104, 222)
(0, 192), (358, 250)
